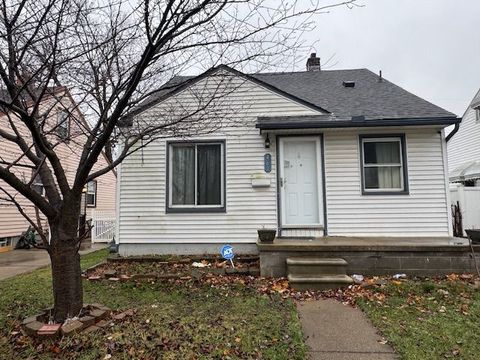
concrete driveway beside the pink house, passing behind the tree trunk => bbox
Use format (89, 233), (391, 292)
(0, 244), (106, 280)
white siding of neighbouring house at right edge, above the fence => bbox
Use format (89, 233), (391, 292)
(447, 91), (480, 172)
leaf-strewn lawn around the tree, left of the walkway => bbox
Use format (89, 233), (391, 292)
(0, 251), (306, 359)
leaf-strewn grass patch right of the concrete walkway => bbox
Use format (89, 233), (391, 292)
(358, 275), (480, 359)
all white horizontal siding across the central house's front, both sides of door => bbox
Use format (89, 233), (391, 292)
(118, 69), (449, 248)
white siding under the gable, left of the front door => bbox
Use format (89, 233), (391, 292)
(118, 72), (318, 243)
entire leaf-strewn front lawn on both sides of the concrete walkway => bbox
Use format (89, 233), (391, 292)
(4, 251), (480, 359)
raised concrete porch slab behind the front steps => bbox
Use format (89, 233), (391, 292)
(257, 236), (480, 277)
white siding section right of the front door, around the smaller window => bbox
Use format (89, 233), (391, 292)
(324, 129), (449, 236)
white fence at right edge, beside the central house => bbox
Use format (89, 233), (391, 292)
(450, 184), (480, 236)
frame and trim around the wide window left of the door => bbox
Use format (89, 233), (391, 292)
(167, 140), (226, 210)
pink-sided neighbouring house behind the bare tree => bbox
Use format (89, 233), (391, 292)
(0, 87), (116, 249)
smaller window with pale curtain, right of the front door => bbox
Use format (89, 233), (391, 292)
(361, 136), (407, 194)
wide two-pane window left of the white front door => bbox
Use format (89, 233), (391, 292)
(168, 142), (225, 211)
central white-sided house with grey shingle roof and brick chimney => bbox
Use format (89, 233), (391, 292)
(117, 54), (459, 255)
